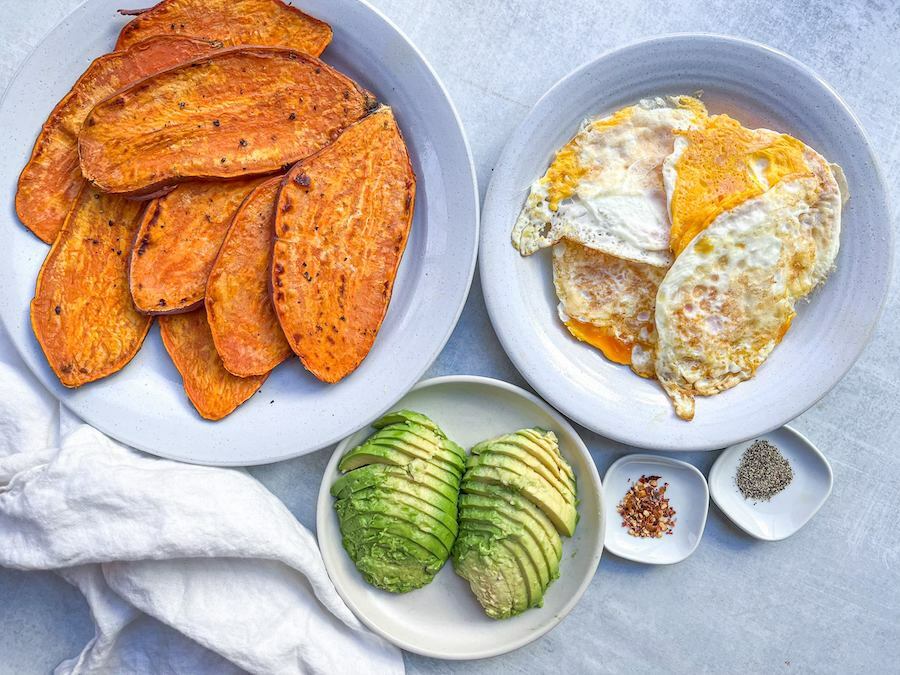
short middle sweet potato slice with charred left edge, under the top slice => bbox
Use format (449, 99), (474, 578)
(128, 178), (264, 314)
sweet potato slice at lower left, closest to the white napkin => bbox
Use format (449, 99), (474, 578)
(31, 186), (153, 387)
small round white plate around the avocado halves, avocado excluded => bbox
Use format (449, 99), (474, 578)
(316, 376), (604, 659)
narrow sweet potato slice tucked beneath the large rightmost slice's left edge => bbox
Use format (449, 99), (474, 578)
(206, 177), (291, 377)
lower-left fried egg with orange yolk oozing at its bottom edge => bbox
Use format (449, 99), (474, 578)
(553, 239), (666, 377)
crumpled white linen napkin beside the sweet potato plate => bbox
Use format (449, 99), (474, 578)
(0, 352), (404, 674)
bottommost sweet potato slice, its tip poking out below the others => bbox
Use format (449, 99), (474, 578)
(159, 307), (268, 420)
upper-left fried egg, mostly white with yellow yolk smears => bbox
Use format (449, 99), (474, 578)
(512, 96), (707, 268)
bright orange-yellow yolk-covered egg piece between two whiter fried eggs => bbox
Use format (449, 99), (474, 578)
(670, 115), (811, 255)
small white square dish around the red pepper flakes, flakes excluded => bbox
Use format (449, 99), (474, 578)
(603, 455), (709, 565)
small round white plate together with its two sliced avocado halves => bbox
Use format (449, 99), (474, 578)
(316, 376), (604, 659)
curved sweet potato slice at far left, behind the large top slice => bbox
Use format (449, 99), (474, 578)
(16, 36), (222, 244)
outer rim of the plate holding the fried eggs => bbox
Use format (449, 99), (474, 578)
(479, 32), (896, 452)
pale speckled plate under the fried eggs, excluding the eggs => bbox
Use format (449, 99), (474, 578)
(480, 35), (893, 450)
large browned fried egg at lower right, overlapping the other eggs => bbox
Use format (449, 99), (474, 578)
(655, 173), (840, 420)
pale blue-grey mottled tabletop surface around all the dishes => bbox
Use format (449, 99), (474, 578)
(0, 0), (900, 674)
